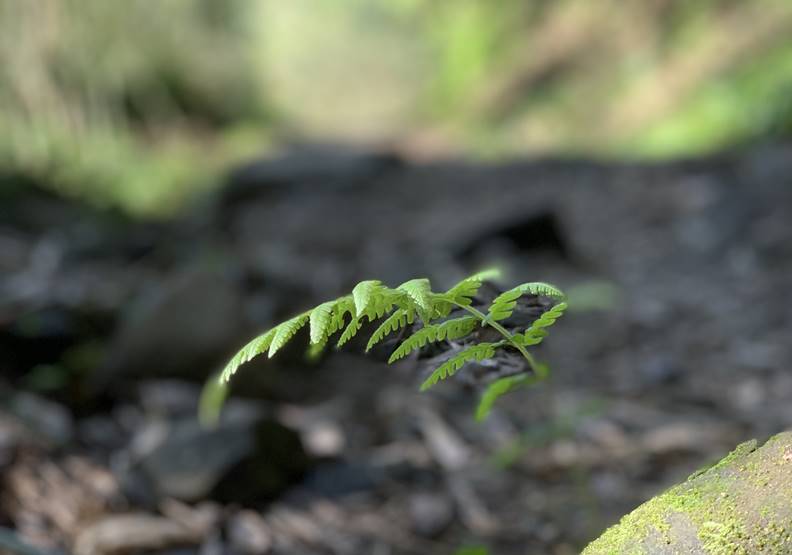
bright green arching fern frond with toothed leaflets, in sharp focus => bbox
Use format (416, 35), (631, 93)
(220, 270), (567, 419)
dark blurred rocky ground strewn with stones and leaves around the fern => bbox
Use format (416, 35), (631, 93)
(0, 146), (792, 555)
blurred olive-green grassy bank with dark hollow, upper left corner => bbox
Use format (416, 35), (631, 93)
(0, 0), (266, 214)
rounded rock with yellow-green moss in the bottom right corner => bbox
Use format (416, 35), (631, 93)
(583, 432), (792, 555)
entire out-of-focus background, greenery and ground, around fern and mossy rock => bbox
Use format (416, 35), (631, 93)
(0, 0), (792, 555)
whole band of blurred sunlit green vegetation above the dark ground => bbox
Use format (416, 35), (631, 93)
(0, 0), (792, 215)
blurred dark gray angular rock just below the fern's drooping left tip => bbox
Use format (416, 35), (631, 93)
(117, 411), (307, 502)
